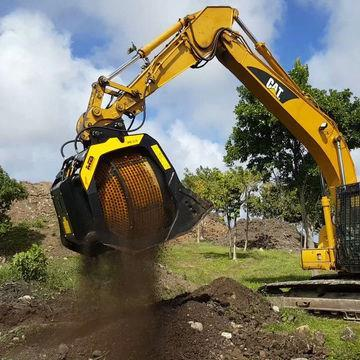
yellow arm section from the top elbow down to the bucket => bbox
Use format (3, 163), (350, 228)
(77, 7), (238, 132)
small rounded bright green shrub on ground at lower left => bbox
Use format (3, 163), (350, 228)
(12, 244), (48, 281)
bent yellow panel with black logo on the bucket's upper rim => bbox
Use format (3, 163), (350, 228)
(80, 134), (144, 190)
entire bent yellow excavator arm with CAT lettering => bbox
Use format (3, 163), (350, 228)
(52, 7), (357, 269)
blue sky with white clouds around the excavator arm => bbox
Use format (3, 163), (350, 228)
(0, 0), (360, 181)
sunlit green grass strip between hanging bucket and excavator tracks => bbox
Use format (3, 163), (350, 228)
(161, 243), (311, 289)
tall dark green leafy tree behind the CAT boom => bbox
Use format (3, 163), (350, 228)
(225, 60), (360, 245)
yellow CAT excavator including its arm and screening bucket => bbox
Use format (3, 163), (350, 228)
(51, 6), (360, 313)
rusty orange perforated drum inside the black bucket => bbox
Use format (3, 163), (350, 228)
(95, 151), (173, 248)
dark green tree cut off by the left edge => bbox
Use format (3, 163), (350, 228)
(0, 166), (27, 234)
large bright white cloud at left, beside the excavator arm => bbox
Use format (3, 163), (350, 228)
(0, 12), (107, 180)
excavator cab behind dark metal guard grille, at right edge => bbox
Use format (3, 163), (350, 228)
(336, 183), (360, 273)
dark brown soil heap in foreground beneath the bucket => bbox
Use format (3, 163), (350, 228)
(0, 278), (325, 360)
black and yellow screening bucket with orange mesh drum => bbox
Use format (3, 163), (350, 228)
(51, 128), (211, 256)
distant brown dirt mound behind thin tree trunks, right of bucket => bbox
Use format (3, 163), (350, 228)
(233, 219), (301, 250)
